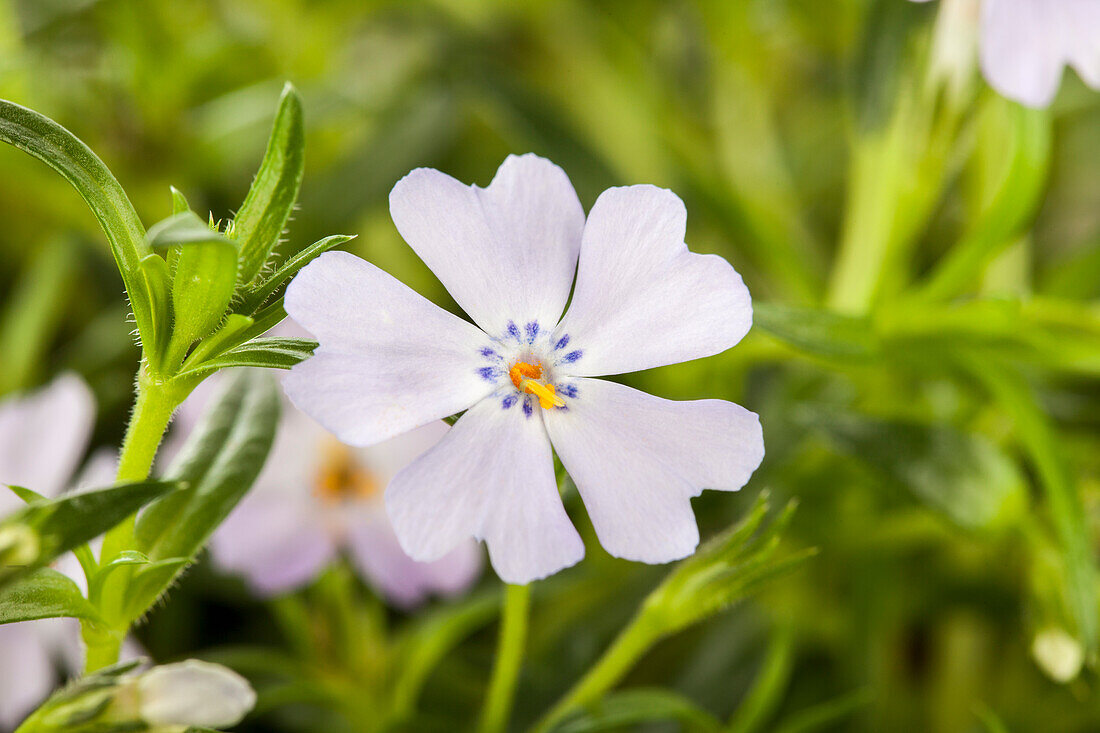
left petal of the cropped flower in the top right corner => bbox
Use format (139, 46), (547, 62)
(980, 0), (1066, 107)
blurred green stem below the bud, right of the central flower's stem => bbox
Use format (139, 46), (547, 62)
(532, 611), (666, 733)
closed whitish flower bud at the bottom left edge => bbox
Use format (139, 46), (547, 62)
(133, 659), (256, 727)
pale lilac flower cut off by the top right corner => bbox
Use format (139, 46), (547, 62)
(915, 0), (1100, 107)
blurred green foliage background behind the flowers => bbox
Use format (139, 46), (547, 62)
(0, 0), (1100, 733)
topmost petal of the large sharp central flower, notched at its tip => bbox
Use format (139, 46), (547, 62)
(389, 154), (584, 336)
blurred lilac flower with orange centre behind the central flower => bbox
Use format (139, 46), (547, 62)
(166, 345), (483, 608)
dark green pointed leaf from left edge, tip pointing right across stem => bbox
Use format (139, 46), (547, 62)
(0, 481), (182, 582)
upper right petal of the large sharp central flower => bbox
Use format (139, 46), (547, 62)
(556, 186), (752, 376)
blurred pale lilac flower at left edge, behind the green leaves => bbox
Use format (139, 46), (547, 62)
(0, 374), (142, 731)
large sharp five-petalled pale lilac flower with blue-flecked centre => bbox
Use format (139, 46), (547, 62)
(284, 155), (763, 583)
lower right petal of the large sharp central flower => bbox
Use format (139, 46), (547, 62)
(543, 379), (763, 562)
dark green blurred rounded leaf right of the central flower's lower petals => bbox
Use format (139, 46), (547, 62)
(814, 411), (1027, 529)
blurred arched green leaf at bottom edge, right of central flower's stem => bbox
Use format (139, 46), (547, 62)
(553, 689), (722, 733)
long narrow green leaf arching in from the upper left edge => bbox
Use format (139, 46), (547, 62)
(0, 99), (149, 327)
